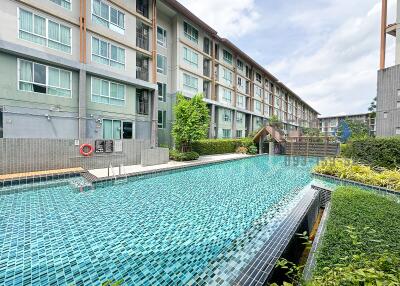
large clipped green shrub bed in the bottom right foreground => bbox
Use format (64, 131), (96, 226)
(311, 187), (400, 285)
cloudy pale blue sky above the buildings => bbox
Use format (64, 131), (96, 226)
(179, 0), (396, 116)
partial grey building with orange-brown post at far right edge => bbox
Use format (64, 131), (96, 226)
(376, 0), (400, 136)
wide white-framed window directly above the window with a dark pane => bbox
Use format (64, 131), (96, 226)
(18, 9), (71, 53)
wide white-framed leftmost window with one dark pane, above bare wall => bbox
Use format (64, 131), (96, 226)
(18, 59), (72, 97)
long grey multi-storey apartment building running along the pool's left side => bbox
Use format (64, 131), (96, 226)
(0, 0), (318, 145)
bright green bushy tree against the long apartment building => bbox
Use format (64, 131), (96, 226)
(172, 93), (210, 151)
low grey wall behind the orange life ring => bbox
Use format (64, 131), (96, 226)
(0, 139), (150, 174)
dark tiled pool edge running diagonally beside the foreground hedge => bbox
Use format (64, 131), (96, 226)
(233, 186), (320, 286)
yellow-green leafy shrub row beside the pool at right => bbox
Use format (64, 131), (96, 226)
(314, 159), (400, 191)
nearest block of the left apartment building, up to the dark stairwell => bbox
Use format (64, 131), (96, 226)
(0, 0), (157, 142)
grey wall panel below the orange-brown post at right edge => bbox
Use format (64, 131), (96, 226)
(376, 65), (400, 136)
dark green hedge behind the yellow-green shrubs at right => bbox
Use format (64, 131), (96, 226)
(341, 137), (400, 169)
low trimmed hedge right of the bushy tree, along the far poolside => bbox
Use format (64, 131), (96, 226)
(192, 138), (253, 155)
